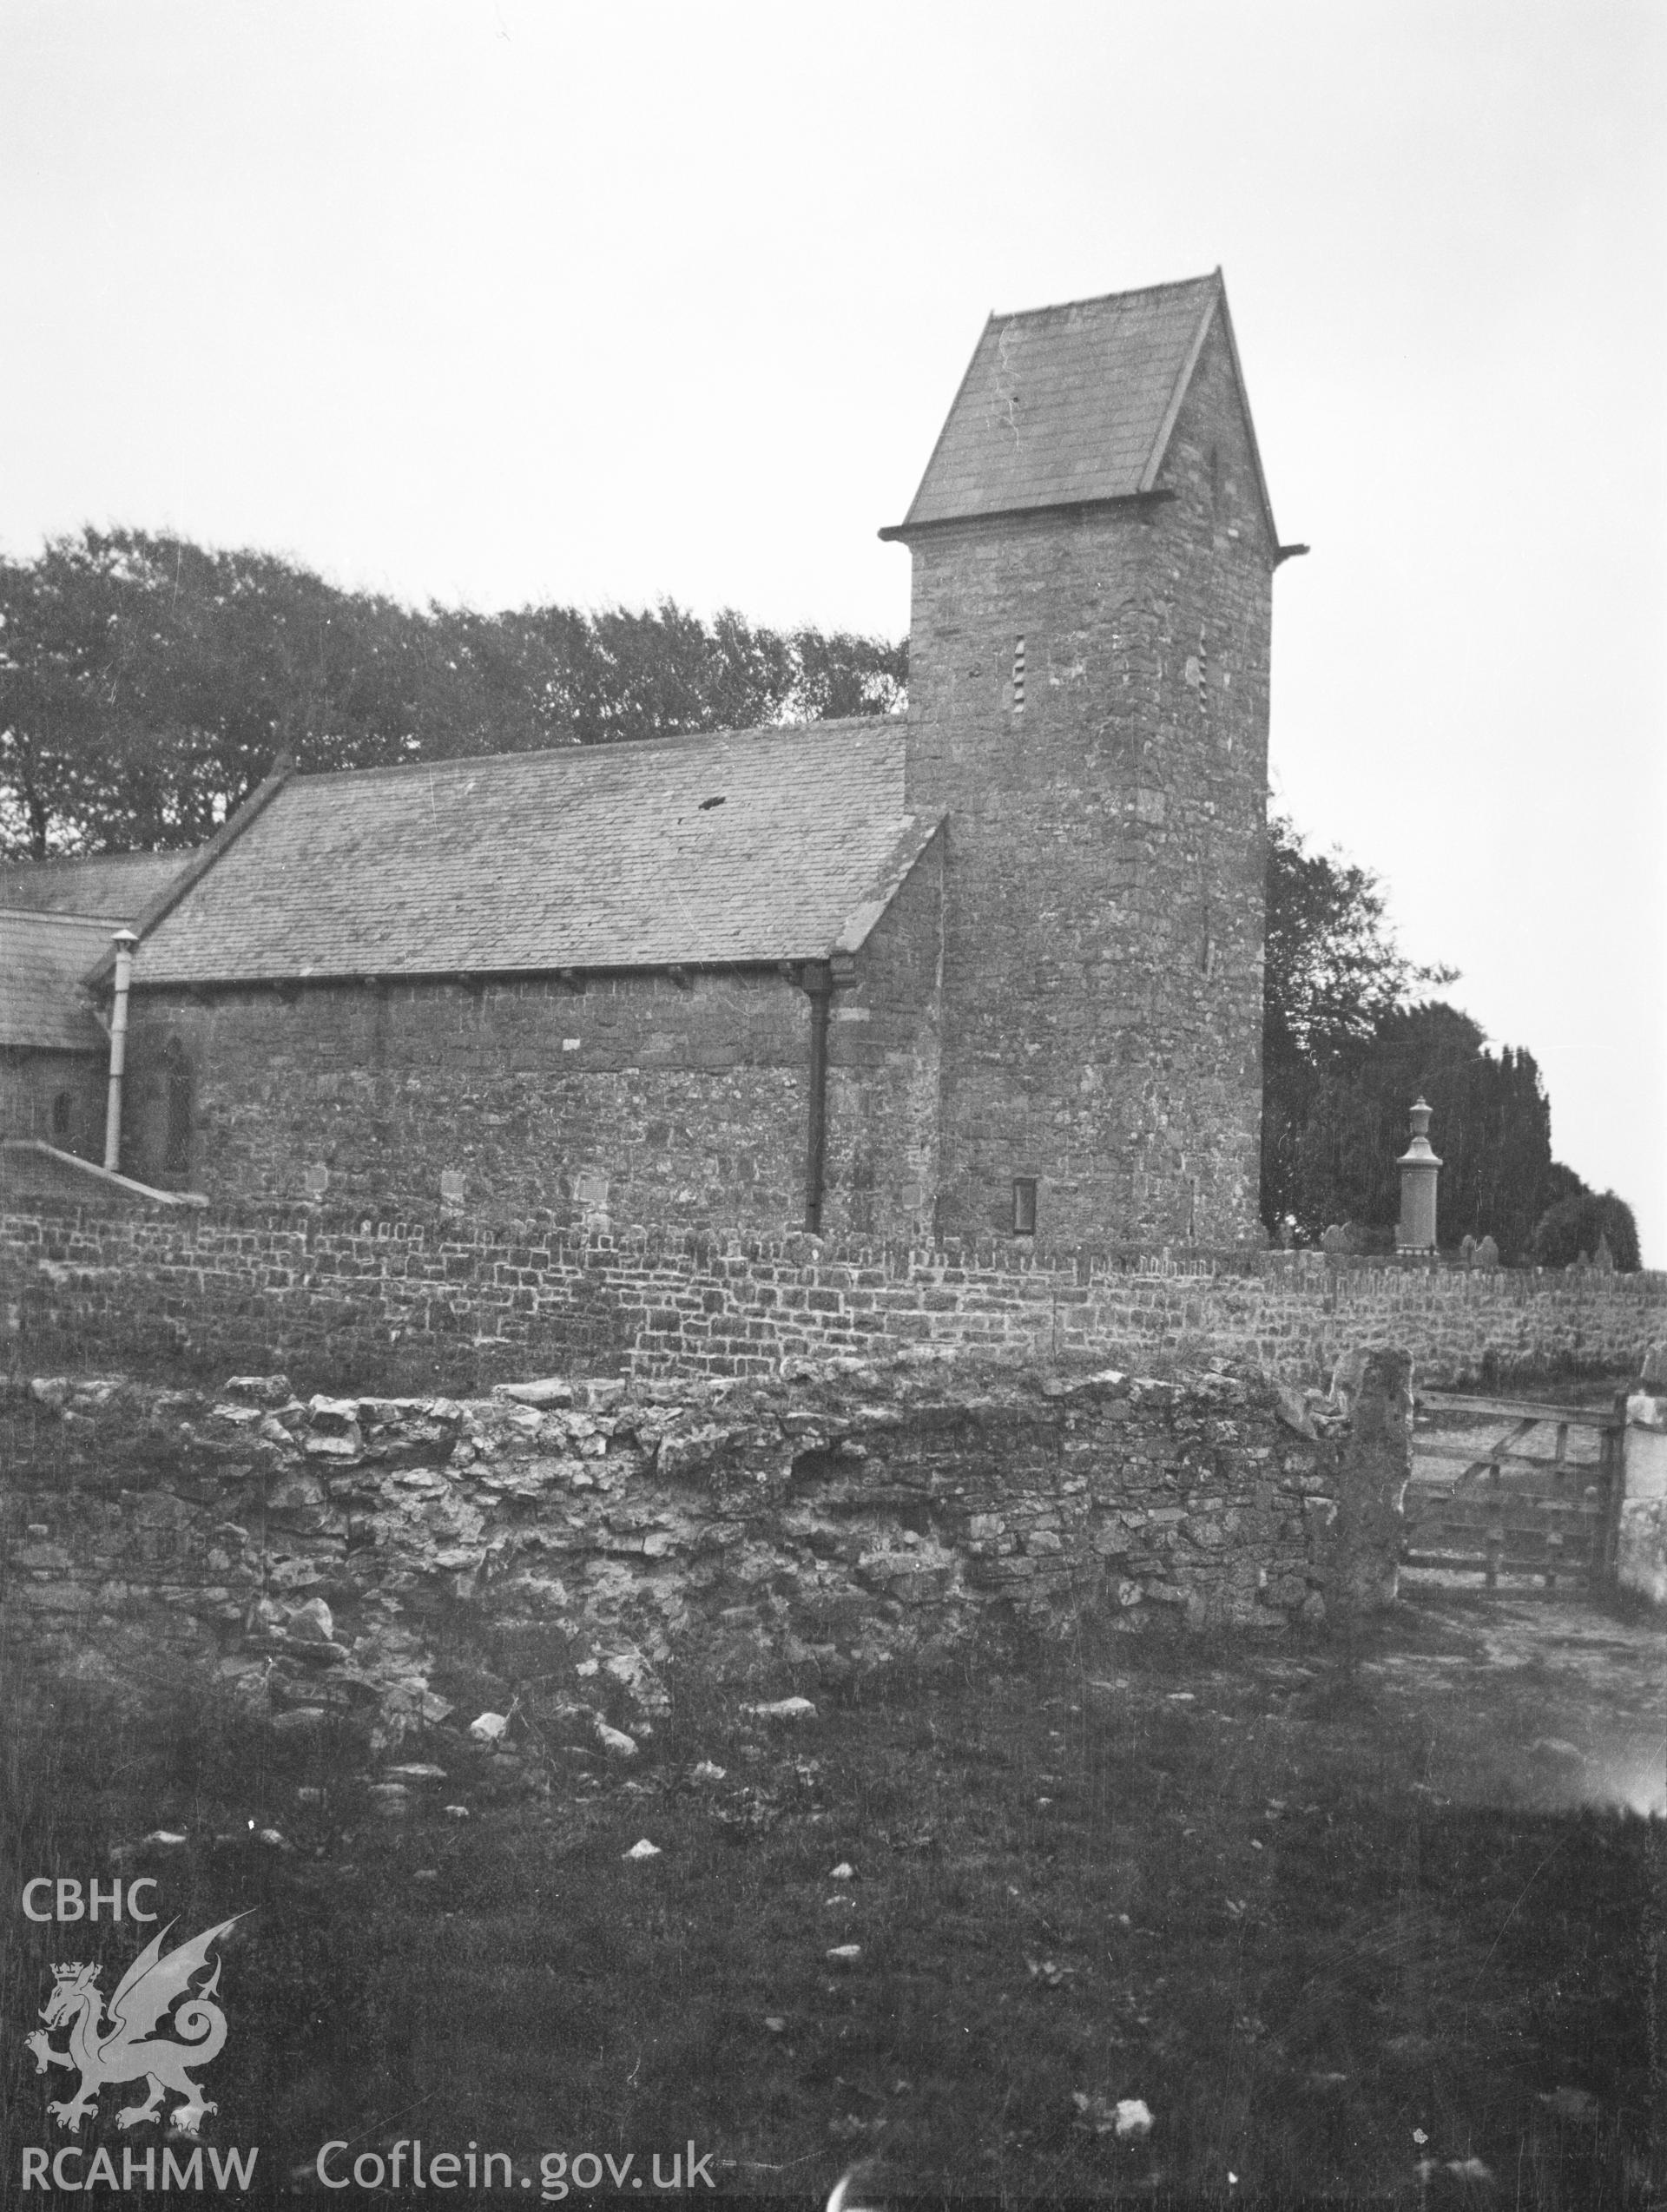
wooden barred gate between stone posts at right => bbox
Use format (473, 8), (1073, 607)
(1401, 1392), (1625, 1590)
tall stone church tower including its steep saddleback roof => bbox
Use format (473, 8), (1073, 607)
(882, 272), (1300, 1246)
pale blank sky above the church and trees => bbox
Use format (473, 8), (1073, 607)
(0, 0), (1667, 1265)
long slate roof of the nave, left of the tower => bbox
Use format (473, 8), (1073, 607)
(120, 719), (938, 986)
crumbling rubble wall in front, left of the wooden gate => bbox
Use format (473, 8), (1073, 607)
(0, 1360), (1348, 1749)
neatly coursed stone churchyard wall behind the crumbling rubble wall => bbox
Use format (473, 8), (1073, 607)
(0, 1206), (1667, 1389)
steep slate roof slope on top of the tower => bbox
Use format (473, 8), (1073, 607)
(880, 270), (1271, 537)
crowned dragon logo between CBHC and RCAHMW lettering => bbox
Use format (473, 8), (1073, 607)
(24, 1913), (243, 2135)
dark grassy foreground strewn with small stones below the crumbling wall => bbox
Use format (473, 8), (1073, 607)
(4, 1599), (1667, 2212)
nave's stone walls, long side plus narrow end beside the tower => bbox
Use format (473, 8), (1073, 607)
(122, 845), (942, 1236)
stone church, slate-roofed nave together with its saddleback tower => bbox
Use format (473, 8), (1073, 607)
(90, 272), (1298, 1246)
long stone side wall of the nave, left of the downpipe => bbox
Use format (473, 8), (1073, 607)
(122, 973), (809, 1226)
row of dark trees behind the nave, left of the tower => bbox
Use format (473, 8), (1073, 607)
(0, 529), (909, 860)
